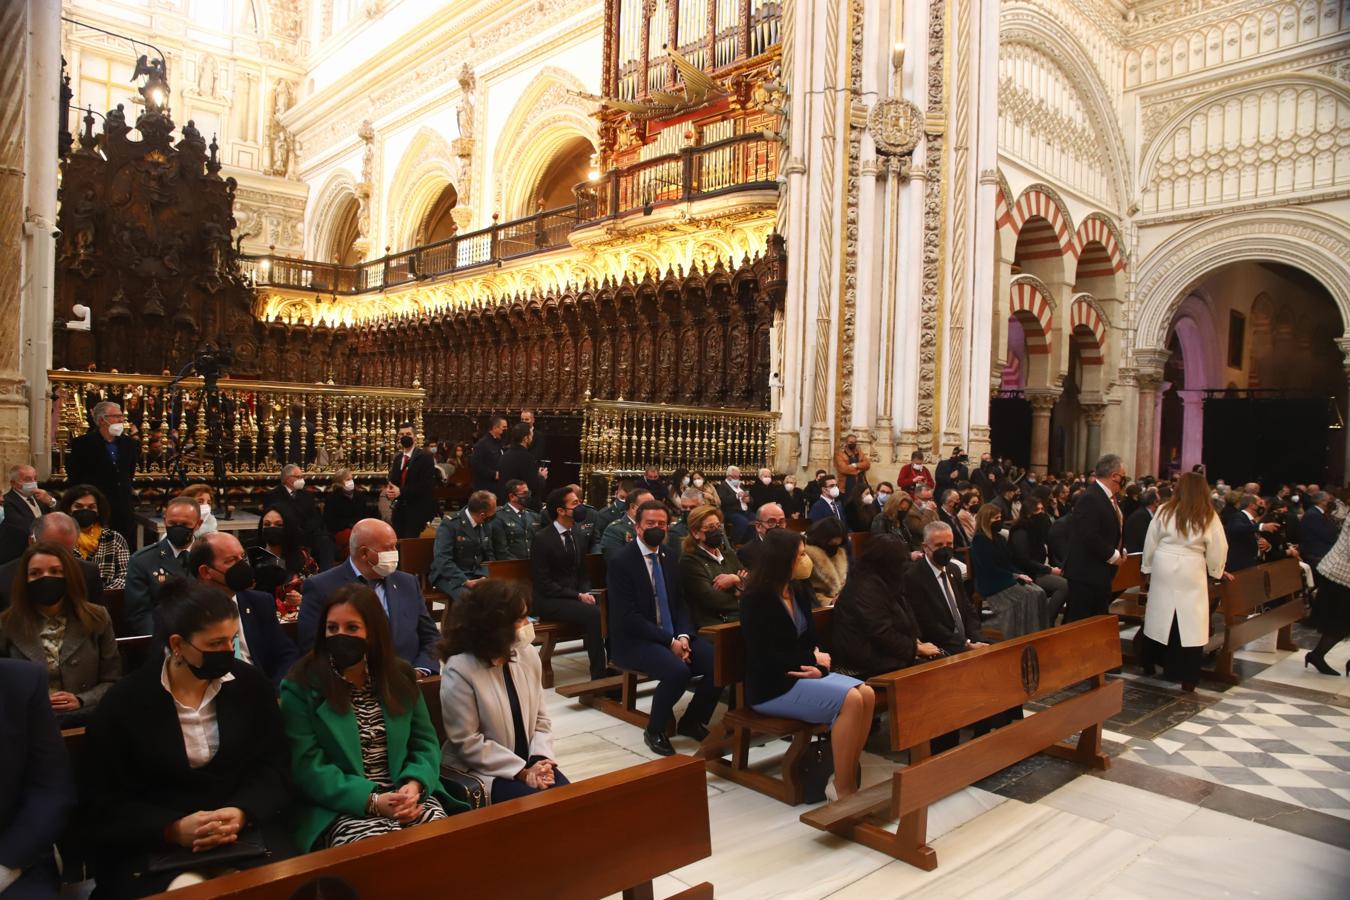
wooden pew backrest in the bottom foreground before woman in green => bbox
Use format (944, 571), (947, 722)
(155, 756), (713, 900)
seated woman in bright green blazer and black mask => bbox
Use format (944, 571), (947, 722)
(281, 584), (466, 850)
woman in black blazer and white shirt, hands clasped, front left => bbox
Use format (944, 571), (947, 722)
(80, 579), (293, 897)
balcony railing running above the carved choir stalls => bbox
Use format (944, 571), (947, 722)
(240, 132), (779, 294)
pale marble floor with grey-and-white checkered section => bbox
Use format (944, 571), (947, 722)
(534, 644), (1350, 900)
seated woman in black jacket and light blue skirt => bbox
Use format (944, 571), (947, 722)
(741, 528), (876, 800)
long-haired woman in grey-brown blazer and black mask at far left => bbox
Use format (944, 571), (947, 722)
(0, 536), (122, 729)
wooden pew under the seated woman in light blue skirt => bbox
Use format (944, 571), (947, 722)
(699, 609), (830, 806)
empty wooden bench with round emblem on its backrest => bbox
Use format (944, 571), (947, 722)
(801, 615), (1125, 869)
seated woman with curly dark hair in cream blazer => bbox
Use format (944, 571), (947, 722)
(440, 579), (567, 803)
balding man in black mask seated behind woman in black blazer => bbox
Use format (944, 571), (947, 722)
(188, 532), (300, 687)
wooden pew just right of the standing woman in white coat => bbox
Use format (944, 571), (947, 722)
(1204, 559), (1308, 684)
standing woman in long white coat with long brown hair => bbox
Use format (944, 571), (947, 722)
(1139, 472), (1231, 691)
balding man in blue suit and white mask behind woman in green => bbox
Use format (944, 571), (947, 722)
(296, 518), (440, 675)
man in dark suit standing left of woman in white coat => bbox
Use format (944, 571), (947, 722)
(1064, 453), (1125, 623)
